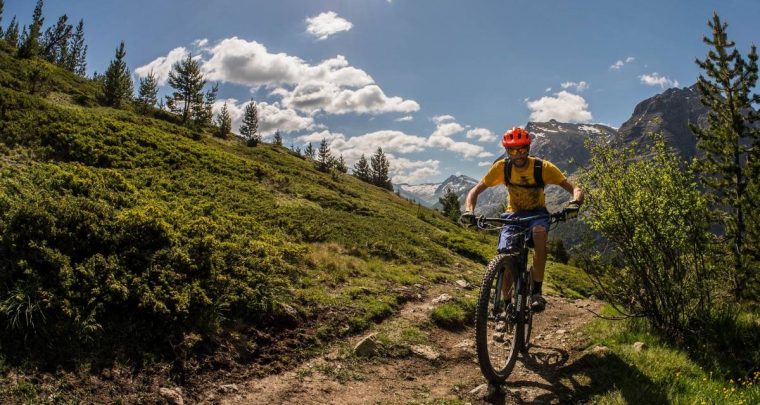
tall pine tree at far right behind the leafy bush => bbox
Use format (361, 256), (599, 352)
(690, 13), (760, 298)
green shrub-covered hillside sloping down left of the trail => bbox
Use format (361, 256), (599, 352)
(0, 44), (502, 372)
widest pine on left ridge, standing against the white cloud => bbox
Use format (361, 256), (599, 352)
(166, 55), (206, 124)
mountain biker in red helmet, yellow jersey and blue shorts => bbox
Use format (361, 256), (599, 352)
(462, 127), (583, 312)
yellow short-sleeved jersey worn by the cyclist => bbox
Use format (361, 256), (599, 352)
(480, 156), (565, 212)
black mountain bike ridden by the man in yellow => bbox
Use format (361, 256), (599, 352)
(475, 209), (577, 384)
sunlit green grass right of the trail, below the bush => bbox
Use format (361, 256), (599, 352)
(559, 309), (760, 404)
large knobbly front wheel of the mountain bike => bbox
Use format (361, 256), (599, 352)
(475, 254), (525, 384)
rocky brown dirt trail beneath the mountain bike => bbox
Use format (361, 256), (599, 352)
(203, 290), (600, 404)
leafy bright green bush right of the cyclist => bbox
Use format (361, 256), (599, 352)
(580, 136), (725, 339)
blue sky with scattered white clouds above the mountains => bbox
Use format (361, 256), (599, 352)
(2, 0), (760, 183)
